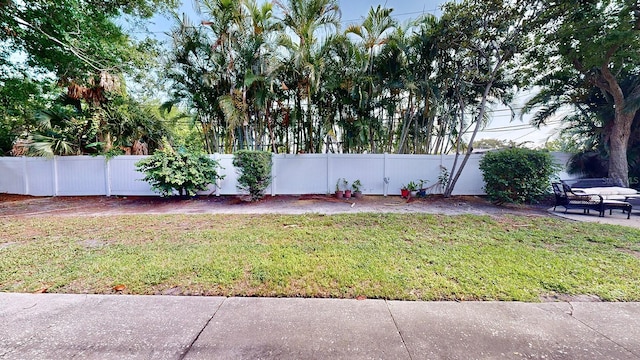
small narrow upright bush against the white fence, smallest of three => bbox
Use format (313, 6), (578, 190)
(233, 150), (271, 201)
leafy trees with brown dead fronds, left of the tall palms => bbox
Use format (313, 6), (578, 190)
(0, 0), (177, 154)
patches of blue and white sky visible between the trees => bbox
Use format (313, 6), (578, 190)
(140, 0), (558, 147)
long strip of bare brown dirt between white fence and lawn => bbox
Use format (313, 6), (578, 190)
(0, 194), (548, 217)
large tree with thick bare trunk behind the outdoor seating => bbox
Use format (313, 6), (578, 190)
(532, 0), (640, 184)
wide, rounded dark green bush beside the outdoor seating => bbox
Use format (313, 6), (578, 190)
(480, 148), (559, 203)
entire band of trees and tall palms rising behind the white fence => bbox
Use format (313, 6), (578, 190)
(0, 0), (640, 193)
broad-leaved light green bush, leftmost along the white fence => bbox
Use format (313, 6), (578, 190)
(136, 146), (224, 196)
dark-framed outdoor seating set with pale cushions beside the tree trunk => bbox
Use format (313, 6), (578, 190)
(552, 178), (640, 219)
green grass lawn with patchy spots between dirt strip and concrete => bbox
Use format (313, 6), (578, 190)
(0, 214), (640, 301)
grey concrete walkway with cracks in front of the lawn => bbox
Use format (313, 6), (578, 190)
(0, 293), (640, 359)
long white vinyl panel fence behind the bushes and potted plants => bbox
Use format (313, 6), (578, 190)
(0, 153), (569, 196)
